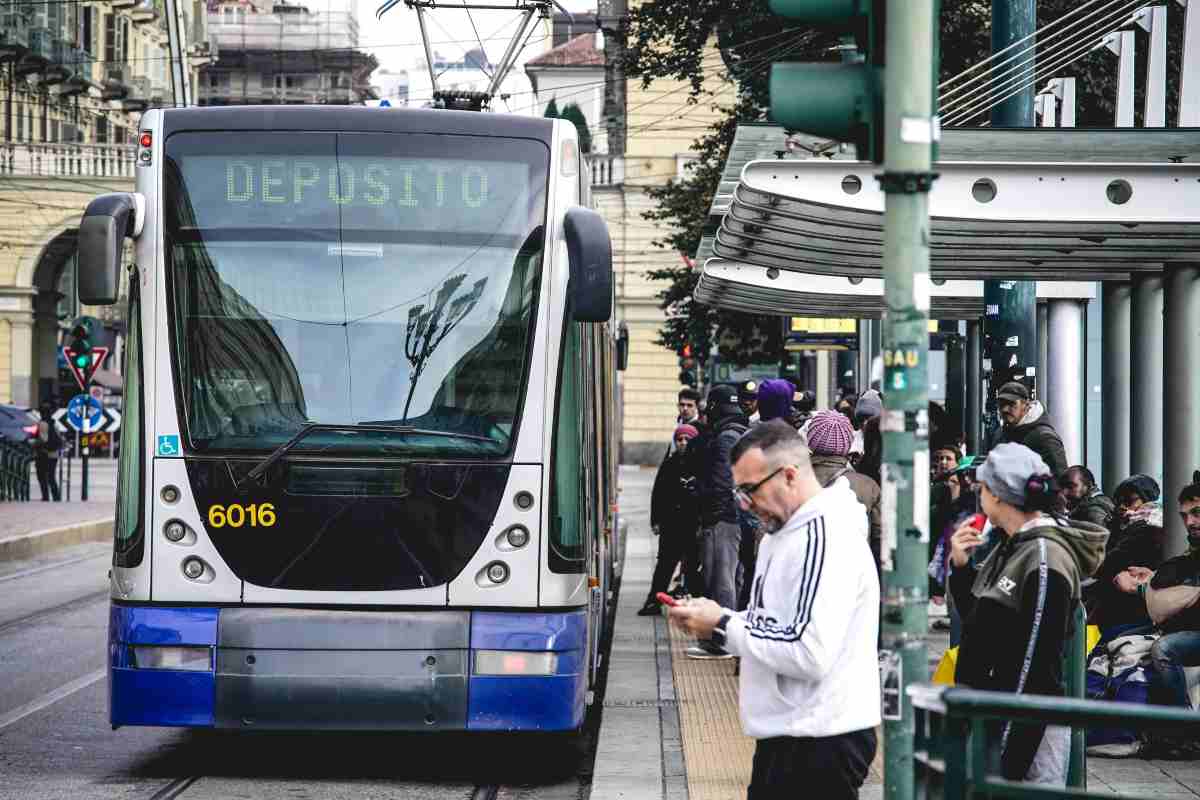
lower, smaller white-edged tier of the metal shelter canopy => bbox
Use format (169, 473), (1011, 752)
(694, 258), (1096, 319)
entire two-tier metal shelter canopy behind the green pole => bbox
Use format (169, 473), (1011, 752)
(695, 124), (1200, 319)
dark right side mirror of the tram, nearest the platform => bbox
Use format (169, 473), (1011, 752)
(563, 206), (612, 323)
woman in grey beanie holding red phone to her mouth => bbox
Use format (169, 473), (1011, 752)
(950, 443), (1108, 786)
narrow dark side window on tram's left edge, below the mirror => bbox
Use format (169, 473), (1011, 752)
(113, 281), (145, 567)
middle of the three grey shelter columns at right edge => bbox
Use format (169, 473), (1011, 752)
(1132, 275), (1163, 485)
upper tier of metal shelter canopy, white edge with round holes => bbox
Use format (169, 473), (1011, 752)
(713, 160), (1200, 281)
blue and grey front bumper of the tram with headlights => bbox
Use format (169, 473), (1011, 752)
(109, 604), (587, 730)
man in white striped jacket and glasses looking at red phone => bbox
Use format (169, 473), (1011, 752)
(671, 420), (880, 800)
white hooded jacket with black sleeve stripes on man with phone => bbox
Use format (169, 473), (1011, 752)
(725, 477), (880, 739)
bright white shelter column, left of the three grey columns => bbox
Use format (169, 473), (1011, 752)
(1043, 300), (1084, 464)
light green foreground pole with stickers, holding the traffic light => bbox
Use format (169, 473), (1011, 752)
(880, 0), (953, 800)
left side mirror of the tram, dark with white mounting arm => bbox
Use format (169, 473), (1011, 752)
(77, 192), (145, 306)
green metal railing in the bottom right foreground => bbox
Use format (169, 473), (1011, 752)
(908, 685), (1200, 800)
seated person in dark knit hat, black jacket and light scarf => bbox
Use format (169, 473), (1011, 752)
(1084, 475), (1164, 638)
